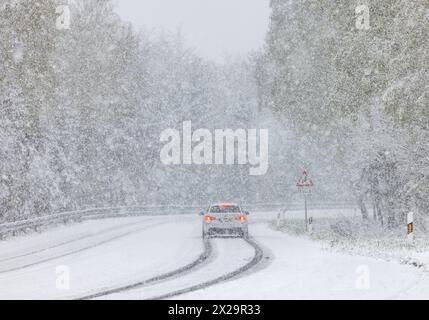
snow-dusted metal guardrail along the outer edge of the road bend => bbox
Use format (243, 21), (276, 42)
(0, 203), (355, 239)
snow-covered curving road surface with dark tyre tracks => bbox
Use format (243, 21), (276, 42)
(0, 213), (429, 299)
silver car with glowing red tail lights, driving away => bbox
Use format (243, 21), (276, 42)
(200, 203), (249, 239)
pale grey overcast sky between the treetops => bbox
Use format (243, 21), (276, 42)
(116, 0), (270, 61)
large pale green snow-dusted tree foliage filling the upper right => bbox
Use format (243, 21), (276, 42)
(257, 0), (429, 227)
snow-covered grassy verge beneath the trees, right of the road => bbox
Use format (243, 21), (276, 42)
(270, 210), (429, 272)
